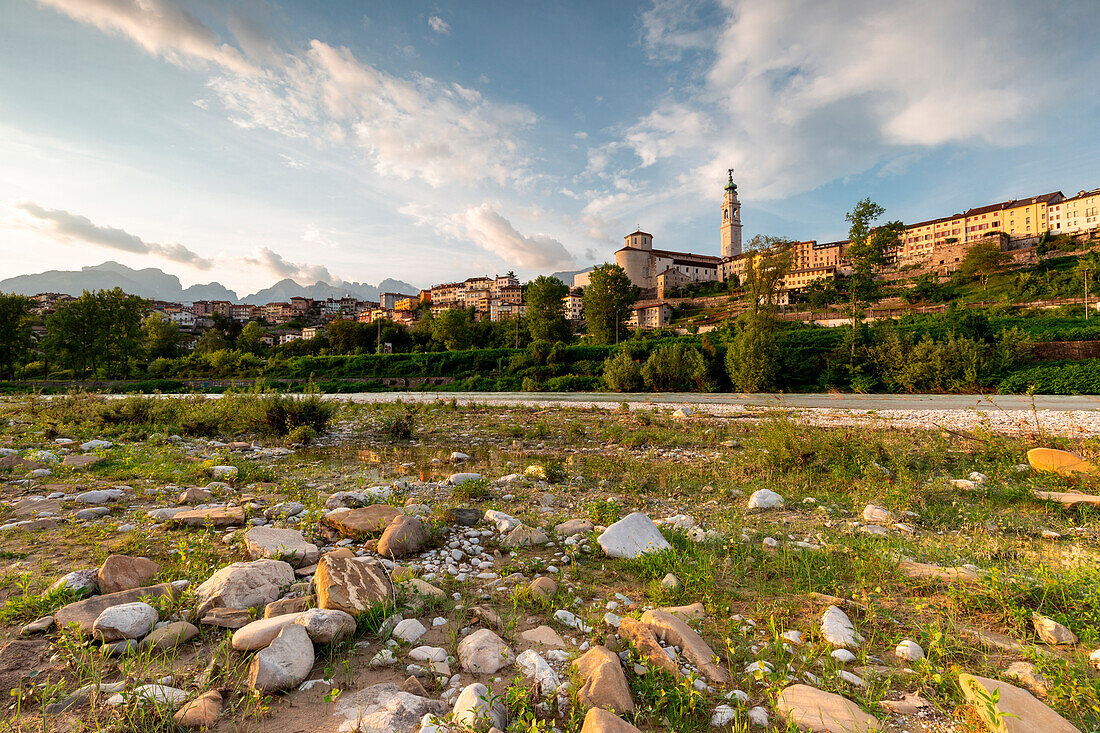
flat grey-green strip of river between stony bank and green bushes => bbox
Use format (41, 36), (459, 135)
(331, 392), (1100, 412)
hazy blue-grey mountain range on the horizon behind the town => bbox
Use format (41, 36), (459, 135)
(0, 262), (420, 305)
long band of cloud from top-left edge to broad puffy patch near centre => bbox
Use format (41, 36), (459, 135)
(40, 0), (536, 186)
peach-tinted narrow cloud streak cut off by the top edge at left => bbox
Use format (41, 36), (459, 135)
(39, 0), (259, 75)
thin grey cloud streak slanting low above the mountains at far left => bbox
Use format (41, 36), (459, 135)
(8, 200), (213, 270)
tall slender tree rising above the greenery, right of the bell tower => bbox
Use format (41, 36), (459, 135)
(845, 198), (905, 373)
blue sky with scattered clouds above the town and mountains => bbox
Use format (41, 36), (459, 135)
(0, 0), (1100, 292)
